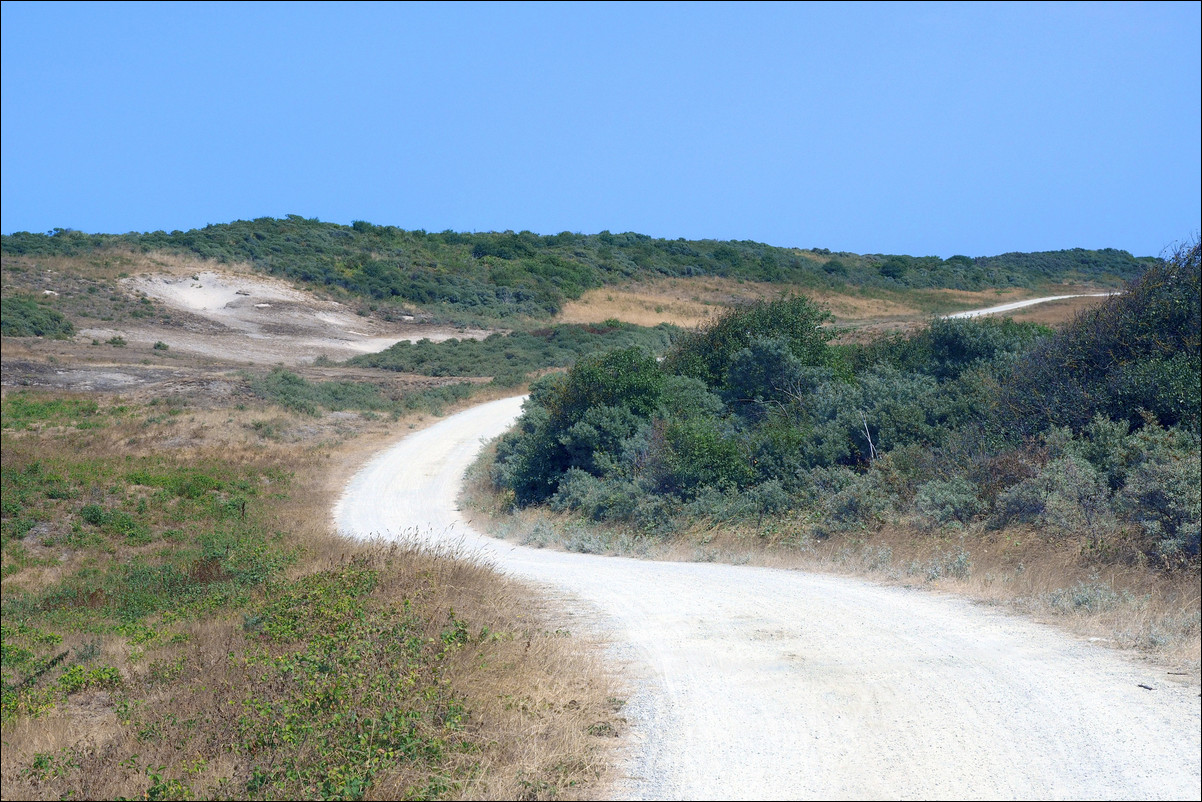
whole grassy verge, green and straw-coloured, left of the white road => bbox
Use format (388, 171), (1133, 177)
(0, 393), (620, 798)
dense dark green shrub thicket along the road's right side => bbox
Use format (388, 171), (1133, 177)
(493, 246), (1202, 566)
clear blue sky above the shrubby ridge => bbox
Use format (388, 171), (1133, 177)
(0, 2), (1202, 257)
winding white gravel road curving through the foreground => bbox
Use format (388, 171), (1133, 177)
(334, 398), (1202, 800)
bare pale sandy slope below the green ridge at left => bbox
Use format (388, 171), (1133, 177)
(4, 251), (490, 366)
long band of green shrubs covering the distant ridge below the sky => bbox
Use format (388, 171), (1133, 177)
(0, 215), (1155, 322)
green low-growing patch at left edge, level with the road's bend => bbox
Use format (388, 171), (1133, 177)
(2, 433), (293, 692)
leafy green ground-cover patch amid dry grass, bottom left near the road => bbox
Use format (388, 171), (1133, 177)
(175, 559), (471, 798)
